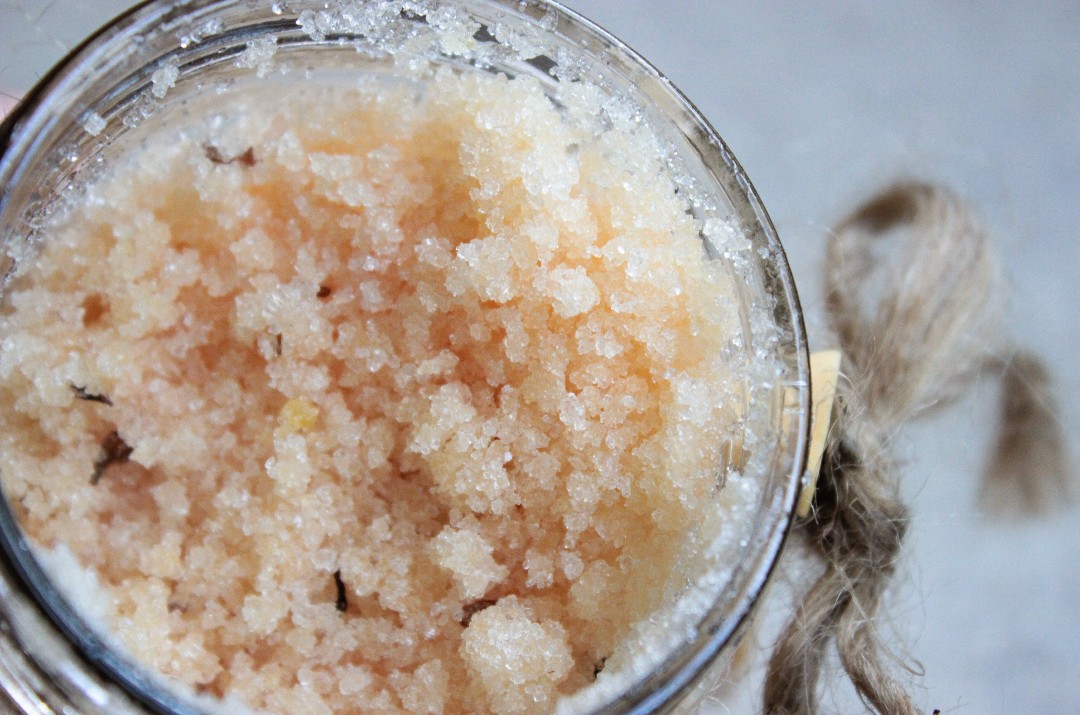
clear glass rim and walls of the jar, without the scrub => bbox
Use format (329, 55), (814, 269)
(0, 0), (810, 714)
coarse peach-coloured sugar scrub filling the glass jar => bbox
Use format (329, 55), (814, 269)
(0, 69), (759, 714)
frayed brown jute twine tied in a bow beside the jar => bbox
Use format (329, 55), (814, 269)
(764, 183), (1071, 715)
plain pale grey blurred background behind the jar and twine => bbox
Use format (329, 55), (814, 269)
(0, 0), (1080, 715)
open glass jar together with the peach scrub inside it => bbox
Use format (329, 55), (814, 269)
(0, 0), (809, 713)
